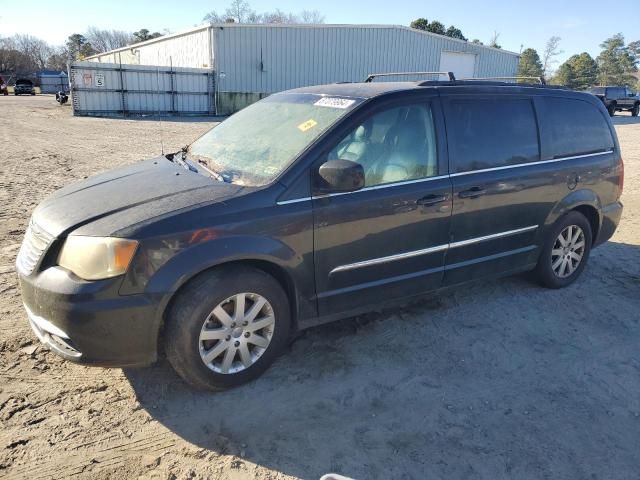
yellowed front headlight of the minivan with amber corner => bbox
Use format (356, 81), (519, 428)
(58, 235), (138, 280)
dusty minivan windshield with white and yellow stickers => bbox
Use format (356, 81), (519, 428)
(187, 93), (363, 187)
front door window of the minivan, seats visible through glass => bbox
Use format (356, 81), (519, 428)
(329, 105), (438, 187)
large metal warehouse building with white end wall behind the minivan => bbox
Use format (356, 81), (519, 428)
(88, 24), (519, 115)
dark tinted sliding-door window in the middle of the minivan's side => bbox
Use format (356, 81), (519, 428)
(447, 98), (540, 173)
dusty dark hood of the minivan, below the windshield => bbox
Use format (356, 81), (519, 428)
(33, 157), (248, 237)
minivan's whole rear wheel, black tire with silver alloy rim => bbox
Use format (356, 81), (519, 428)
(535, 210), (593, 288)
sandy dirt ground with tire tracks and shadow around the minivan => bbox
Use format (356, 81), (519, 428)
(0, 96), (640, 480)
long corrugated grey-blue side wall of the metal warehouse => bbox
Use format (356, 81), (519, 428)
(212, 25), (518, 93)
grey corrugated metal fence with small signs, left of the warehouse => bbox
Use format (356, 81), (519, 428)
(69, 62), (216, 117)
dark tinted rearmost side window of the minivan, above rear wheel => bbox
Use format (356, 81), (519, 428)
(541, 97), (613, 158)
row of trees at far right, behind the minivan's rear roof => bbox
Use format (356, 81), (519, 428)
(518, 33), (640, 90)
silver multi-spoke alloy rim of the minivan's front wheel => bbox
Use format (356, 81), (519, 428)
(198, 292), (275, 374)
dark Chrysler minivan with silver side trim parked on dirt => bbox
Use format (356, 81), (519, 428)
(17, 76), (624, 389)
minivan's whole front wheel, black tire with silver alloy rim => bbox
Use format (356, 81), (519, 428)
(164, 266), (291, 391)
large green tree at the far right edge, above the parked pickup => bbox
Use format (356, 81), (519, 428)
(596, 33), (638, 86)
